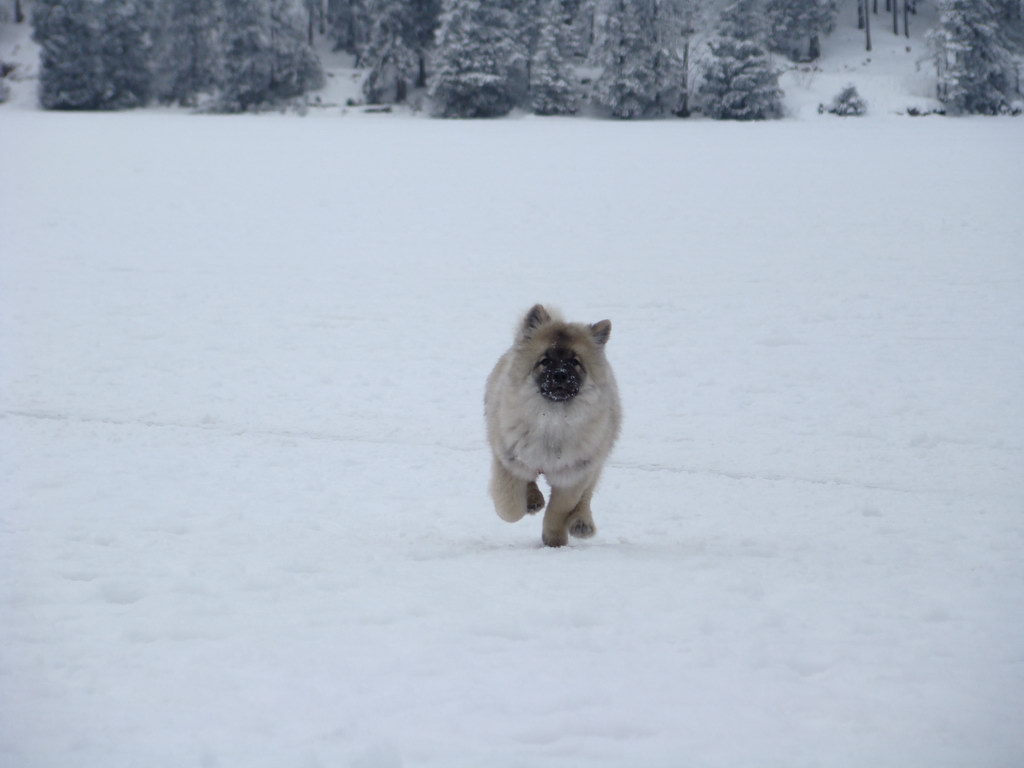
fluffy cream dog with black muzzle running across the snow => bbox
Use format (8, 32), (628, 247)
(484, 304), (622, 547)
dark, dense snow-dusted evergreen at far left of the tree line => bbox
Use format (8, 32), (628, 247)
(33, 0), (152, 110)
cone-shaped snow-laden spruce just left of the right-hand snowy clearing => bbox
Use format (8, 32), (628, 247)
(699, 0), (782, 120)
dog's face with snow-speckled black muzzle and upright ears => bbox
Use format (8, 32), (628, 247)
(519, 304), (611, 402)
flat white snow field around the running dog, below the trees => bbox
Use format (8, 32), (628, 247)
(0, 110), (1024, 768)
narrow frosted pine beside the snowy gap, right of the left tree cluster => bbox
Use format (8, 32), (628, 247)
(359, 0), (419, 103)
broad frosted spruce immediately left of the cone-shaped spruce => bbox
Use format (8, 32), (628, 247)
(593, 0), (680, 119)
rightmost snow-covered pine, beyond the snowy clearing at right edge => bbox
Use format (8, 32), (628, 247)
(929, 0), (1016, 115)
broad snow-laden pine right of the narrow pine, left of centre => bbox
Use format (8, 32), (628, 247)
(430, 0), (517, 118)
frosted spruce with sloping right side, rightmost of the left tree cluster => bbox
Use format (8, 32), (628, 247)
(219, 0), (324, 112)
